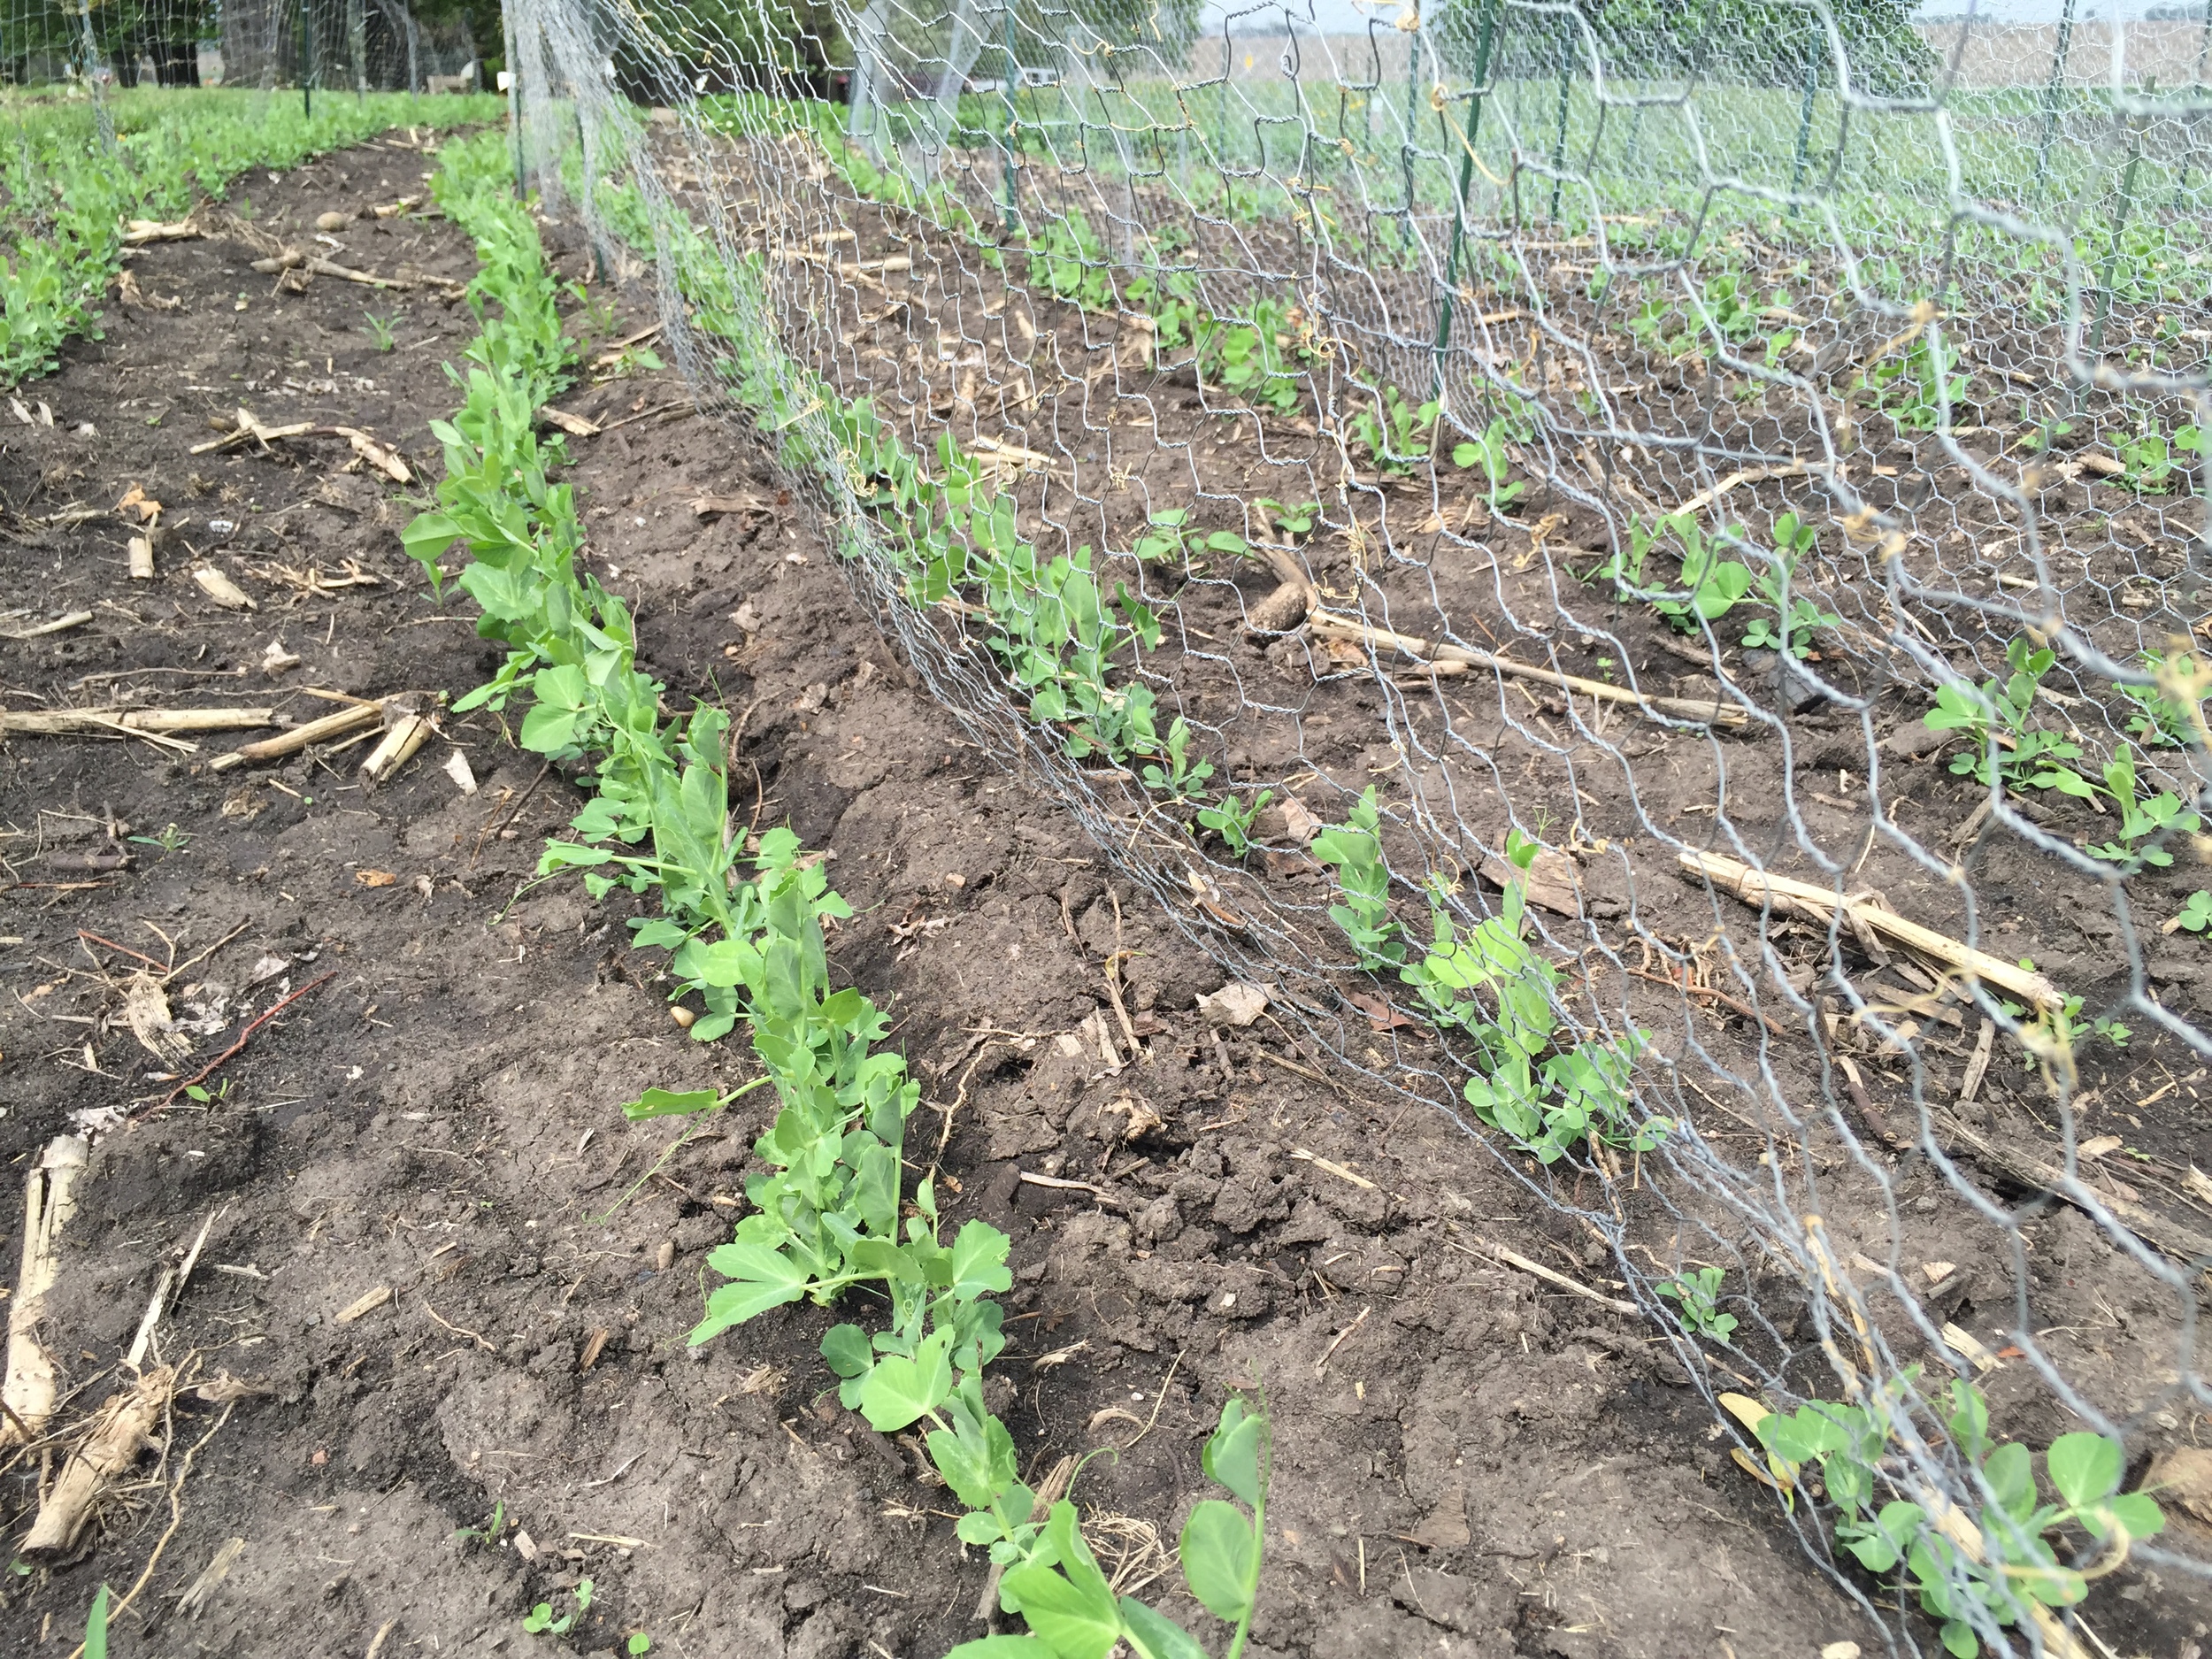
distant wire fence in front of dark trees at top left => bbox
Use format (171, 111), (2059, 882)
(0, 0), (480, 97)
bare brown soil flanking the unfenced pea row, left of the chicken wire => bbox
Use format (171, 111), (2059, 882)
(0, 149), (2203, 1659)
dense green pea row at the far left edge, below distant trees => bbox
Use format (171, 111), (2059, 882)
(0, 91), (495, 388)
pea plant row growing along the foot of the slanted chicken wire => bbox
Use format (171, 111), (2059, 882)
(584, 146), (2163, 1655)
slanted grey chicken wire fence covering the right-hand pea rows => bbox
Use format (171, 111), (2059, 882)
(509, 0), (2212, 1655)
